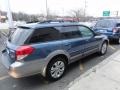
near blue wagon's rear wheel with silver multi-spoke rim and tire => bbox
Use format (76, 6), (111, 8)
(46, 57), (67, 81)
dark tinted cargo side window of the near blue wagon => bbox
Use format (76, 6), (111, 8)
(30, 28), (59, 43)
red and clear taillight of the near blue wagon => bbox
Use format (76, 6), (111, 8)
(15, 46), (34, 60)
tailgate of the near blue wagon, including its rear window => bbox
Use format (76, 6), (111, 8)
(2, 27), (33, 67)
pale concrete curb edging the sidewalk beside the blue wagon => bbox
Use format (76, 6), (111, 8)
(64, 50), (120, 90)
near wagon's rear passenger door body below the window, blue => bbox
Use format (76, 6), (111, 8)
(62, 38), (85, 63)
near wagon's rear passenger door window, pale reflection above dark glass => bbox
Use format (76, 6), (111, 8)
(60, 26), (81, 39)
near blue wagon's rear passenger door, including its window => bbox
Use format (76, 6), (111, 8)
(60, 26), (85, 62)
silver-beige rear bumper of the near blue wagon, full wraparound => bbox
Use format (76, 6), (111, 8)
(2, 52), (46, 78)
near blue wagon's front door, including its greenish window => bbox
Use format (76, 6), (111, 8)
(79, 26), (102, 55)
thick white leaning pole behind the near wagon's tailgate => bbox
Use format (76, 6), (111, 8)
(6, 0), (14, 30)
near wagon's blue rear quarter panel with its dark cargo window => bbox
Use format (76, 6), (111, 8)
(26, 27), (61, 60)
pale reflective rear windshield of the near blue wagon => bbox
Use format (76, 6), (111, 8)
(9, 28), (33, 45)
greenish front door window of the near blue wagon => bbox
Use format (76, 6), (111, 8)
(79, 26), (93, 37)
